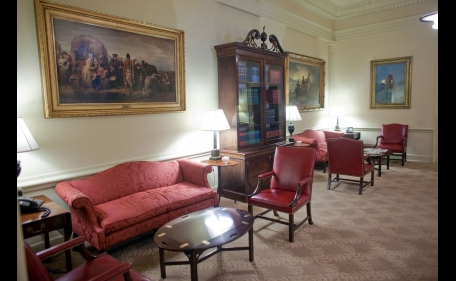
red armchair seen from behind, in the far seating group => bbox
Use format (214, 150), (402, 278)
(327, 138), (375, 195)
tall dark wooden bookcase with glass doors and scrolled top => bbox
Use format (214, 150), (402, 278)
(214, 30), (290, 202)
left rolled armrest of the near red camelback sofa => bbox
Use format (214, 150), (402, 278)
(55, 181), (102, 232)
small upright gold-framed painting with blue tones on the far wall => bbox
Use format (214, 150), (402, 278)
(370, 57), (412, 109)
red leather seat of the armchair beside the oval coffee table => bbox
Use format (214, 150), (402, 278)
(247, 189), (310, 214)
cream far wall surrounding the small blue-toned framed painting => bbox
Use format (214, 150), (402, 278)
(331, 26), (438, 161)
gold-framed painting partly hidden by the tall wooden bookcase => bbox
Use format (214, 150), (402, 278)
(285, 52), (326, 112)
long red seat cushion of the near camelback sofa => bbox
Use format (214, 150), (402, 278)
(95, 182), (214, 234)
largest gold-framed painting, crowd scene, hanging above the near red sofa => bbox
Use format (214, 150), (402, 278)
(35, 0), (185, 118)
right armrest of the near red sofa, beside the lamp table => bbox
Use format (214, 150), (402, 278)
(176, 159), (212, 188)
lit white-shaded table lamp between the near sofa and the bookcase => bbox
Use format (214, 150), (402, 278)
(201, 109), (230, 161)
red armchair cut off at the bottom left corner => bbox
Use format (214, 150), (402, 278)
(24, 236), (150, 281)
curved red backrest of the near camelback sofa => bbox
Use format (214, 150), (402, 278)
(71, 161), (183, 205)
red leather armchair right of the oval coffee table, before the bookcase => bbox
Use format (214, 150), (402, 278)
(247, 146), (315, 242)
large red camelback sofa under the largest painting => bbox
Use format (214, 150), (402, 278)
(55, 159), (218, 251)
